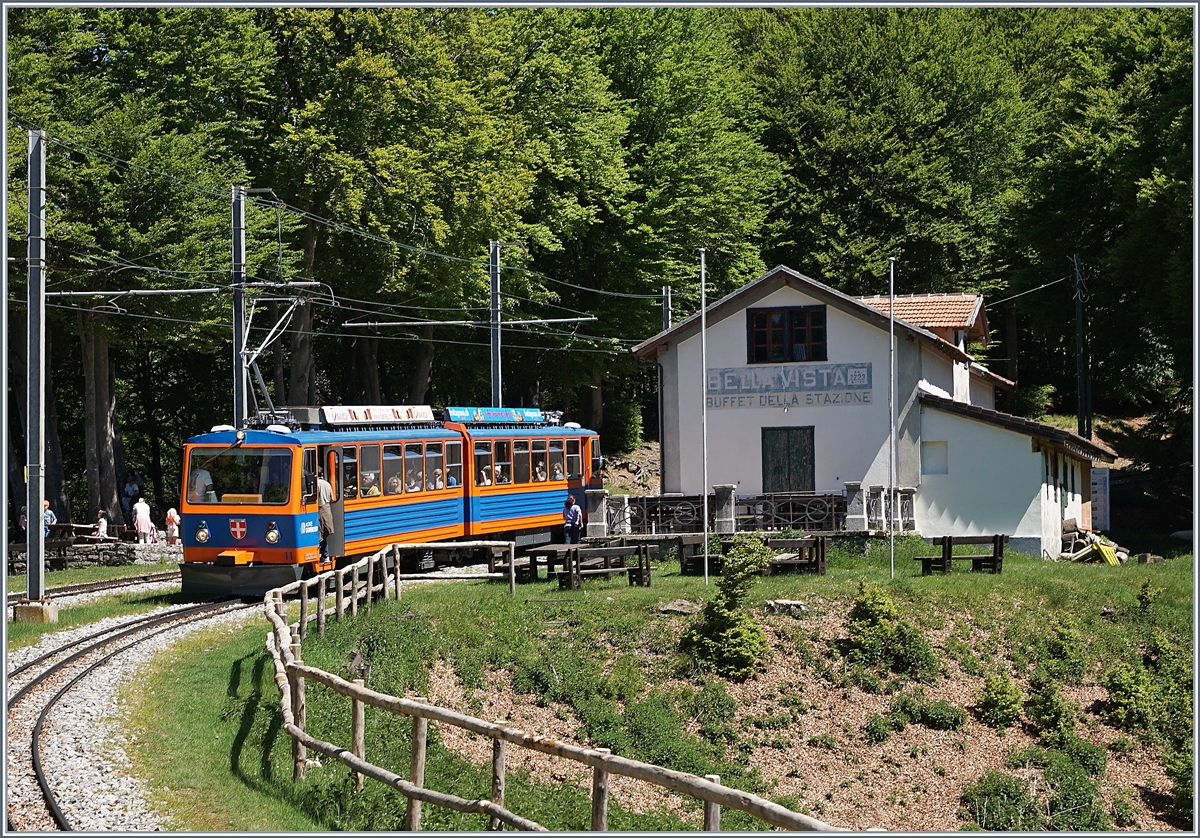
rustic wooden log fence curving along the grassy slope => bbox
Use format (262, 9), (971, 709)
(263, 543), (844, 832)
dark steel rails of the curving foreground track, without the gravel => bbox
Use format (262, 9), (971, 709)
(7, 603), (253, 832)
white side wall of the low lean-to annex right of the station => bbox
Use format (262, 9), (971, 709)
(914, 407), (1061, 555)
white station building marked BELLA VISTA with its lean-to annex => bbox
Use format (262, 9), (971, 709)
(632, 267), (1114, 556)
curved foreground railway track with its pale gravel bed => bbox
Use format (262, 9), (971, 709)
(6, 601), (259, 831)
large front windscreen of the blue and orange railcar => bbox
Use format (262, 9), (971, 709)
(187, 447), (294, 504)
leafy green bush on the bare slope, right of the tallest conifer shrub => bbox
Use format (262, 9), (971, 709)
(847, 581), (941, 682)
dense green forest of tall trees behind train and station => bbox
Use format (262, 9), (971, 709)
(5, 7), (1194, 526)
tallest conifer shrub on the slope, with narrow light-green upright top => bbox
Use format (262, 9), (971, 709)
(680, 535), (770, 681)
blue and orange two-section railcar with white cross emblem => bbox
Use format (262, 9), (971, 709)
(180, 406), (604, 595)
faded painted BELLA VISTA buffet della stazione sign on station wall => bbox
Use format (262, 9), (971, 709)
(707, 363), (871, 409)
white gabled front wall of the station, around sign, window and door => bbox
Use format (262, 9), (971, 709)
(661, 287), (919, 495)
